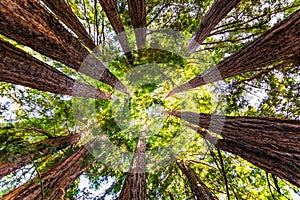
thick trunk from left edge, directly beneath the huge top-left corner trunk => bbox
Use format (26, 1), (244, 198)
(0, 39), (110, 99)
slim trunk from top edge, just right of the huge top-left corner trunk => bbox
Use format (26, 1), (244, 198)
(43, 0), (96, 50)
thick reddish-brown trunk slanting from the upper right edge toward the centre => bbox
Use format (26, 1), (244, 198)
(169, 10), (300, 96)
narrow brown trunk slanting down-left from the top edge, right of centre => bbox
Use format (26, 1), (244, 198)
(188, 0), (241, 51)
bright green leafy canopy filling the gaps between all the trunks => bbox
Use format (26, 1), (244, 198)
(0, 0), (300, 199)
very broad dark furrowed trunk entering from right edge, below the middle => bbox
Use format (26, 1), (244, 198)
(169, 111), (300, 187)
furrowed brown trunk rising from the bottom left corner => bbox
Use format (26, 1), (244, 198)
(0, 147), (89, 200)
